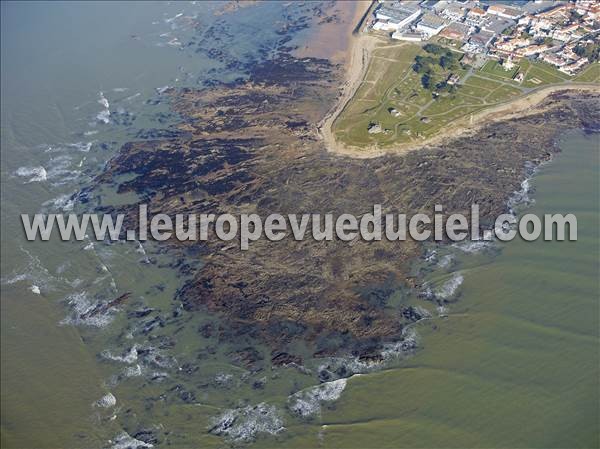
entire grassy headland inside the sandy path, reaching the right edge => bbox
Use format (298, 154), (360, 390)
(333, 43), (600, 147)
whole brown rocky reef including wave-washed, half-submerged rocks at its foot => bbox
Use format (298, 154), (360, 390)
(77, 7), (600, 445)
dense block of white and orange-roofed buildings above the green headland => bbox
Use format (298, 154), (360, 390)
(370, 0), (600, 76)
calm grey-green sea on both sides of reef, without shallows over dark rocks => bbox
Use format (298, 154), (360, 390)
(0, 3), (600, 448)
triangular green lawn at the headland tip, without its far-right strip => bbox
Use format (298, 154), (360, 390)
(334, 44), (520, 146)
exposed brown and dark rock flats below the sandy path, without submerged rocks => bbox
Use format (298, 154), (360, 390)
(96, 42), (600, 364)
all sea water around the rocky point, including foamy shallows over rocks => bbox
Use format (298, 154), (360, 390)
(0, 2), (600, 448)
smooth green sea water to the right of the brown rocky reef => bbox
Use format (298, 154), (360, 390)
(278, 133), (600, 448)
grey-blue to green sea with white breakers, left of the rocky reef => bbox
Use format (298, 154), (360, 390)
(0, 1), (330, 448)
